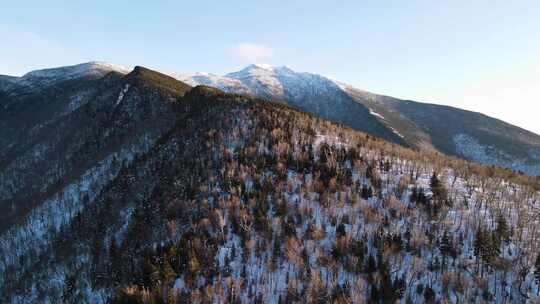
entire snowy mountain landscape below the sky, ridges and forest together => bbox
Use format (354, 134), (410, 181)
(0, 62), (540, 303)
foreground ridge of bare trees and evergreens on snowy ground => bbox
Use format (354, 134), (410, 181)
(0, 67), (540, 303)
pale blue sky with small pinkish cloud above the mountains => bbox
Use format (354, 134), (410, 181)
(0, 0), (540, 133)
